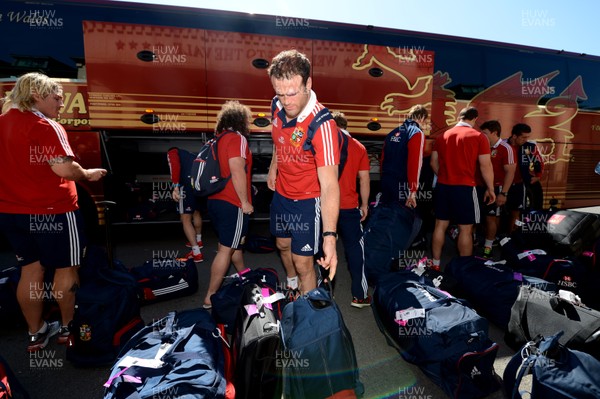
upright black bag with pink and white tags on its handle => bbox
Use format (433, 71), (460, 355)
(231, 284), (284, 399)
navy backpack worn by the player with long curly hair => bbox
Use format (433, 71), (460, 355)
(190, 131), (235, 197)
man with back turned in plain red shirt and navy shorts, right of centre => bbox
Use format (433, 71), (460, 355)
(431, 107), (496, 267)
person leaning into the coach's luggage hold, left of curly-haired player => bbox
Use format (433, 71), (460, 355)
(167, 147), (204, 263)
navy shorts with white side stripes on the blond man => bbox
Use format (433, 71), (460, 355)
(0, 210), (86, 269)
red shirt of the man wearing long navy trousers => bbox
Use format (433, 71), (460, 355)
(339, 137), (371, 209)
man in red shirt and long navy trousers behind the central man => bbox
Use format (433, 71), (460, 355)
(333, 112), (371, 309)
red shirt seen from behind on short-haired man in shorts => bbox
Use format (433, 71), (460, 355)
(433, 124), (490, 187)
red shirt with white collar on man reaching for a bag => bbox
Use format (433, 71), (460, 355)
(271, 92), (340, 200)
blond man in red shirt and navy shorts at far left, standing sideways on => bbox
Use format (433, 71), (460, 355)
(0, 73), (106, 352)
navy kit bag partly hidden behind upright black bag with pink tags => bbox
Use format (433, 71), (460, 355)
(210, 268), (283, 334)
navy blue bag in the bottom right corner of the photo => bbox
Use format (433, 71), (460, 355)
(503, 332), (600, 399)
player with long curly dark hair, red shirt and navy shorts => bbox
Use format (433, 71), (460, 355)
(203, 101), (254, 309)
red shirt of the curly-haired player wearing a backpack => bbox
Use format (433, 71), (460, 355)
(208, 132), (252, 208)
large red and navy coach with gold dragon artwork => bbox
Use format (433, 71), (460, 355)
(0, 0), (600, 231)
